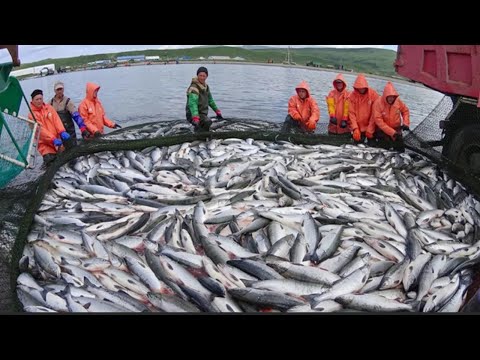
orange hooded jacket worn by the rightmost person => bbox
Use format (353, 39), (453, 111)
(372, 81), (410, 137)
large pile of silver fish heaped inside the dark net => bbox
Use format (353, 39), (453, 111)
(17, 138), (480, 312)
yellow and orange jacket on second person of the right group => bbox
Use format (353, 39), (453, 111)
(326, 74), (351, 134)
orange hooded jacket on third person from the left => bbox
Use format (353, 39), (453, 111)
(78, 82), (115, 135)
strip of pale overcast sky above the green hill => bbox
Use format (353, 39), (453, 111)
(0, 45), (397, 64)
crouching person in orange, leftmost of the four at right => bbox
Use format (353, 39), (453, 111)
(282, 81), (320, 133)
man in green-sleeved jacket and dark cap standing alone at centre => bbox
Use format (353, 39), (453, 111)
(185, 66), (223, 132)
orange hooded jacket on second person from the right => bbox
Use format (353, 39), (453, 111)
(348, 74), (380, 134)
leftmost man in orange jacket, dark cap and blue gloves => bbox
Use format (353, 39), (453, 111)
(28, 89), (71, 165)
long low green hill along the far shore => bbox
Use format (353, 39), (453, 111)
(18, 46), (396, 76)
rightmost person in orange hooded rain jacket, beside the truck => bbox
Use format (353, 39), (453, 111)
(372, 81), (410, 152)
